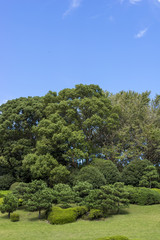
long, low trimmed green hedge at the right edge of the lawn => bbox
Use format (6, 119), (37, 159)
(126, 186), (160, 205)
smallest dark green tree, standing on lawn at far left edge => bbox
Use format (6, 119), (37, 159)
(0, 193), (18, 218)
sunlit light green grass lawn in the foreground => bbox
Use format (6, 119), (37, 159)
(0, 205), (160, 240)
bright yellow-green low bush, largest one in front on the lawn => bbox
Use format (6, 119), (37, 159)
(48, 207), (77, 224)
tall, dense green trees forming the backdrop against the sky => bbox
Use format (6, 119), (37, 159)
(0, 84), (160, 188)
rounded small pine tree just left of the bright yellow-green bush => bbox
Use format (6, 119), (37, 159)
(23, 180), (53, 218)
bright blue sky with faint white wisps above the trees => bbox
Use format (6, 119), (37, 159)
(0, 0), (160, 104)
